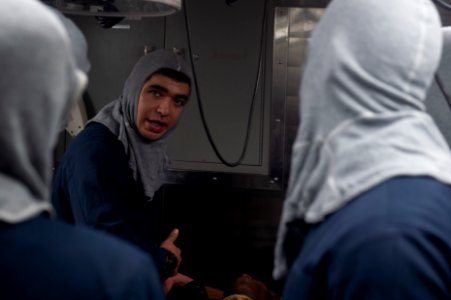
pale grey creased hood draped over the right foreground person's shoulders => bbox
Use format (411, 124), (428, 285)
(274, 0), (451, 278)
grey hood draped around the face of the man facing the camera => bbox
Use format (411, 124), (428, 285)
(92, 49), (191, 198)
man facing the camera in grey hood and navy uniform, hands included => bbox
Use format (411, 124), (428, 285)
(52, 49), (204, 288)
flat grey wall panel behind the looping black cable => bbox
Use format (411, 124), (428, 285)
(165, 0), (271, 175)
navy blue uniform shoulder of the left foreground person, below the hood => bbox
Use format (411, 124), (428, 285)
(0, 215), (166, 300)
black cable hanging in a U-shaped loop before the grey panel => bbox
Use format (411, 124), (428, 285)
(183, 0), (268, 167)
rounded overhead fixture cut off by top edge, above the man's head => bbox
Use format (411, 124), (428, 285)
(43, 0), (182, 17)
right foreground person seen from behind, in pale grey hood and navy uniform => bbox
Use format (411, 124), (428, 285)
(273, 0), (451, 300)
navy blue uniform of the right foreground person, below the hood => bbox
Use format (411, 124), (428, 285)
(284, 177), (451, 300)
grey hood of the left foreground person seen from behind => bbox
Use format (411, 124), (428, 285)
(0, 0), (86, 223)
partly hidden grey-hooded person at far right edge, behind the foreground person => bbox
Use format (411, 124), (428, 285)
(425, 27), (451, 145)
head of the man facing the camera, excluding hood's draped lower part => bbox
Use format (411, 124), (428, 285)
(124, 50), (191, 141)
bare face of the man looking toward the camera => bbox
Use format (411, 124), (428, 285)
(136, 74), (190, 141)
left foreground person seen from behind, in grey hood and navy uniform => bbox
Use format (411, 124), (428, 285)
(0, 0), (164, 300)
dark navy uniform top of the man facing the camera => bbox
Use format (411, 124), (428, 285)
(53, 124), (167, 270)
